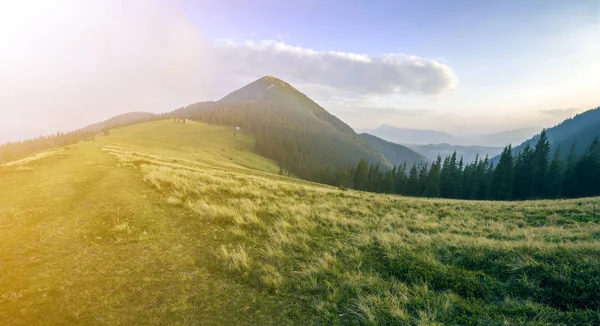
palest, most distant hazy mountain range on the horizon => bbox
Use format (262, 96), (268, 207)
(357, 124), (542, 146)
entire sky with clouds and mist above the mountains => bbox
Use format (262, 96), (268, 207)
(0, 0), (600, 142)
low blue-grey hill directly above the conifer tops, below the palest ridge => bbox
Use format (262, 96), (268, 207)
(403, 143), (503, 163)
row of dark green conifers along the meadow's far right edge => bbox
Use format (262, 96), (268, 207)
(337, 130), (600, 200)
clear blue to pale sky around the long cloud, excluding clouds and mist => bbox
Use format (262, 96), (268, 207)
(185, 0), (600, 132)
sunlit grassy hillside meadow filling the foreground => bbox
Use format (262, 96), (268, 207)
(0, 121), (600, 325)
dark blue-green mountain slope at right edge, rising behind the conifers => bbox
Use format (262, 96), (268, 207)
(504, 107), (600, 160)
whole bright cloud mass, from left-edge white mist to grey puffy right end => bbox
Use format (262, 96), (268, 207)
(0, 0), (457, 142)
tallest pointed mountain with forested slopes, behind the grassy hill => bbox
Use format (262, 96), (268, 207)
(173, 76), (392, 183)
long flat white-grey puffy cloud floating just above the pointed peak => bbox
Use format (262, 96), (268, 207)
(214, 40), (458, 95)
